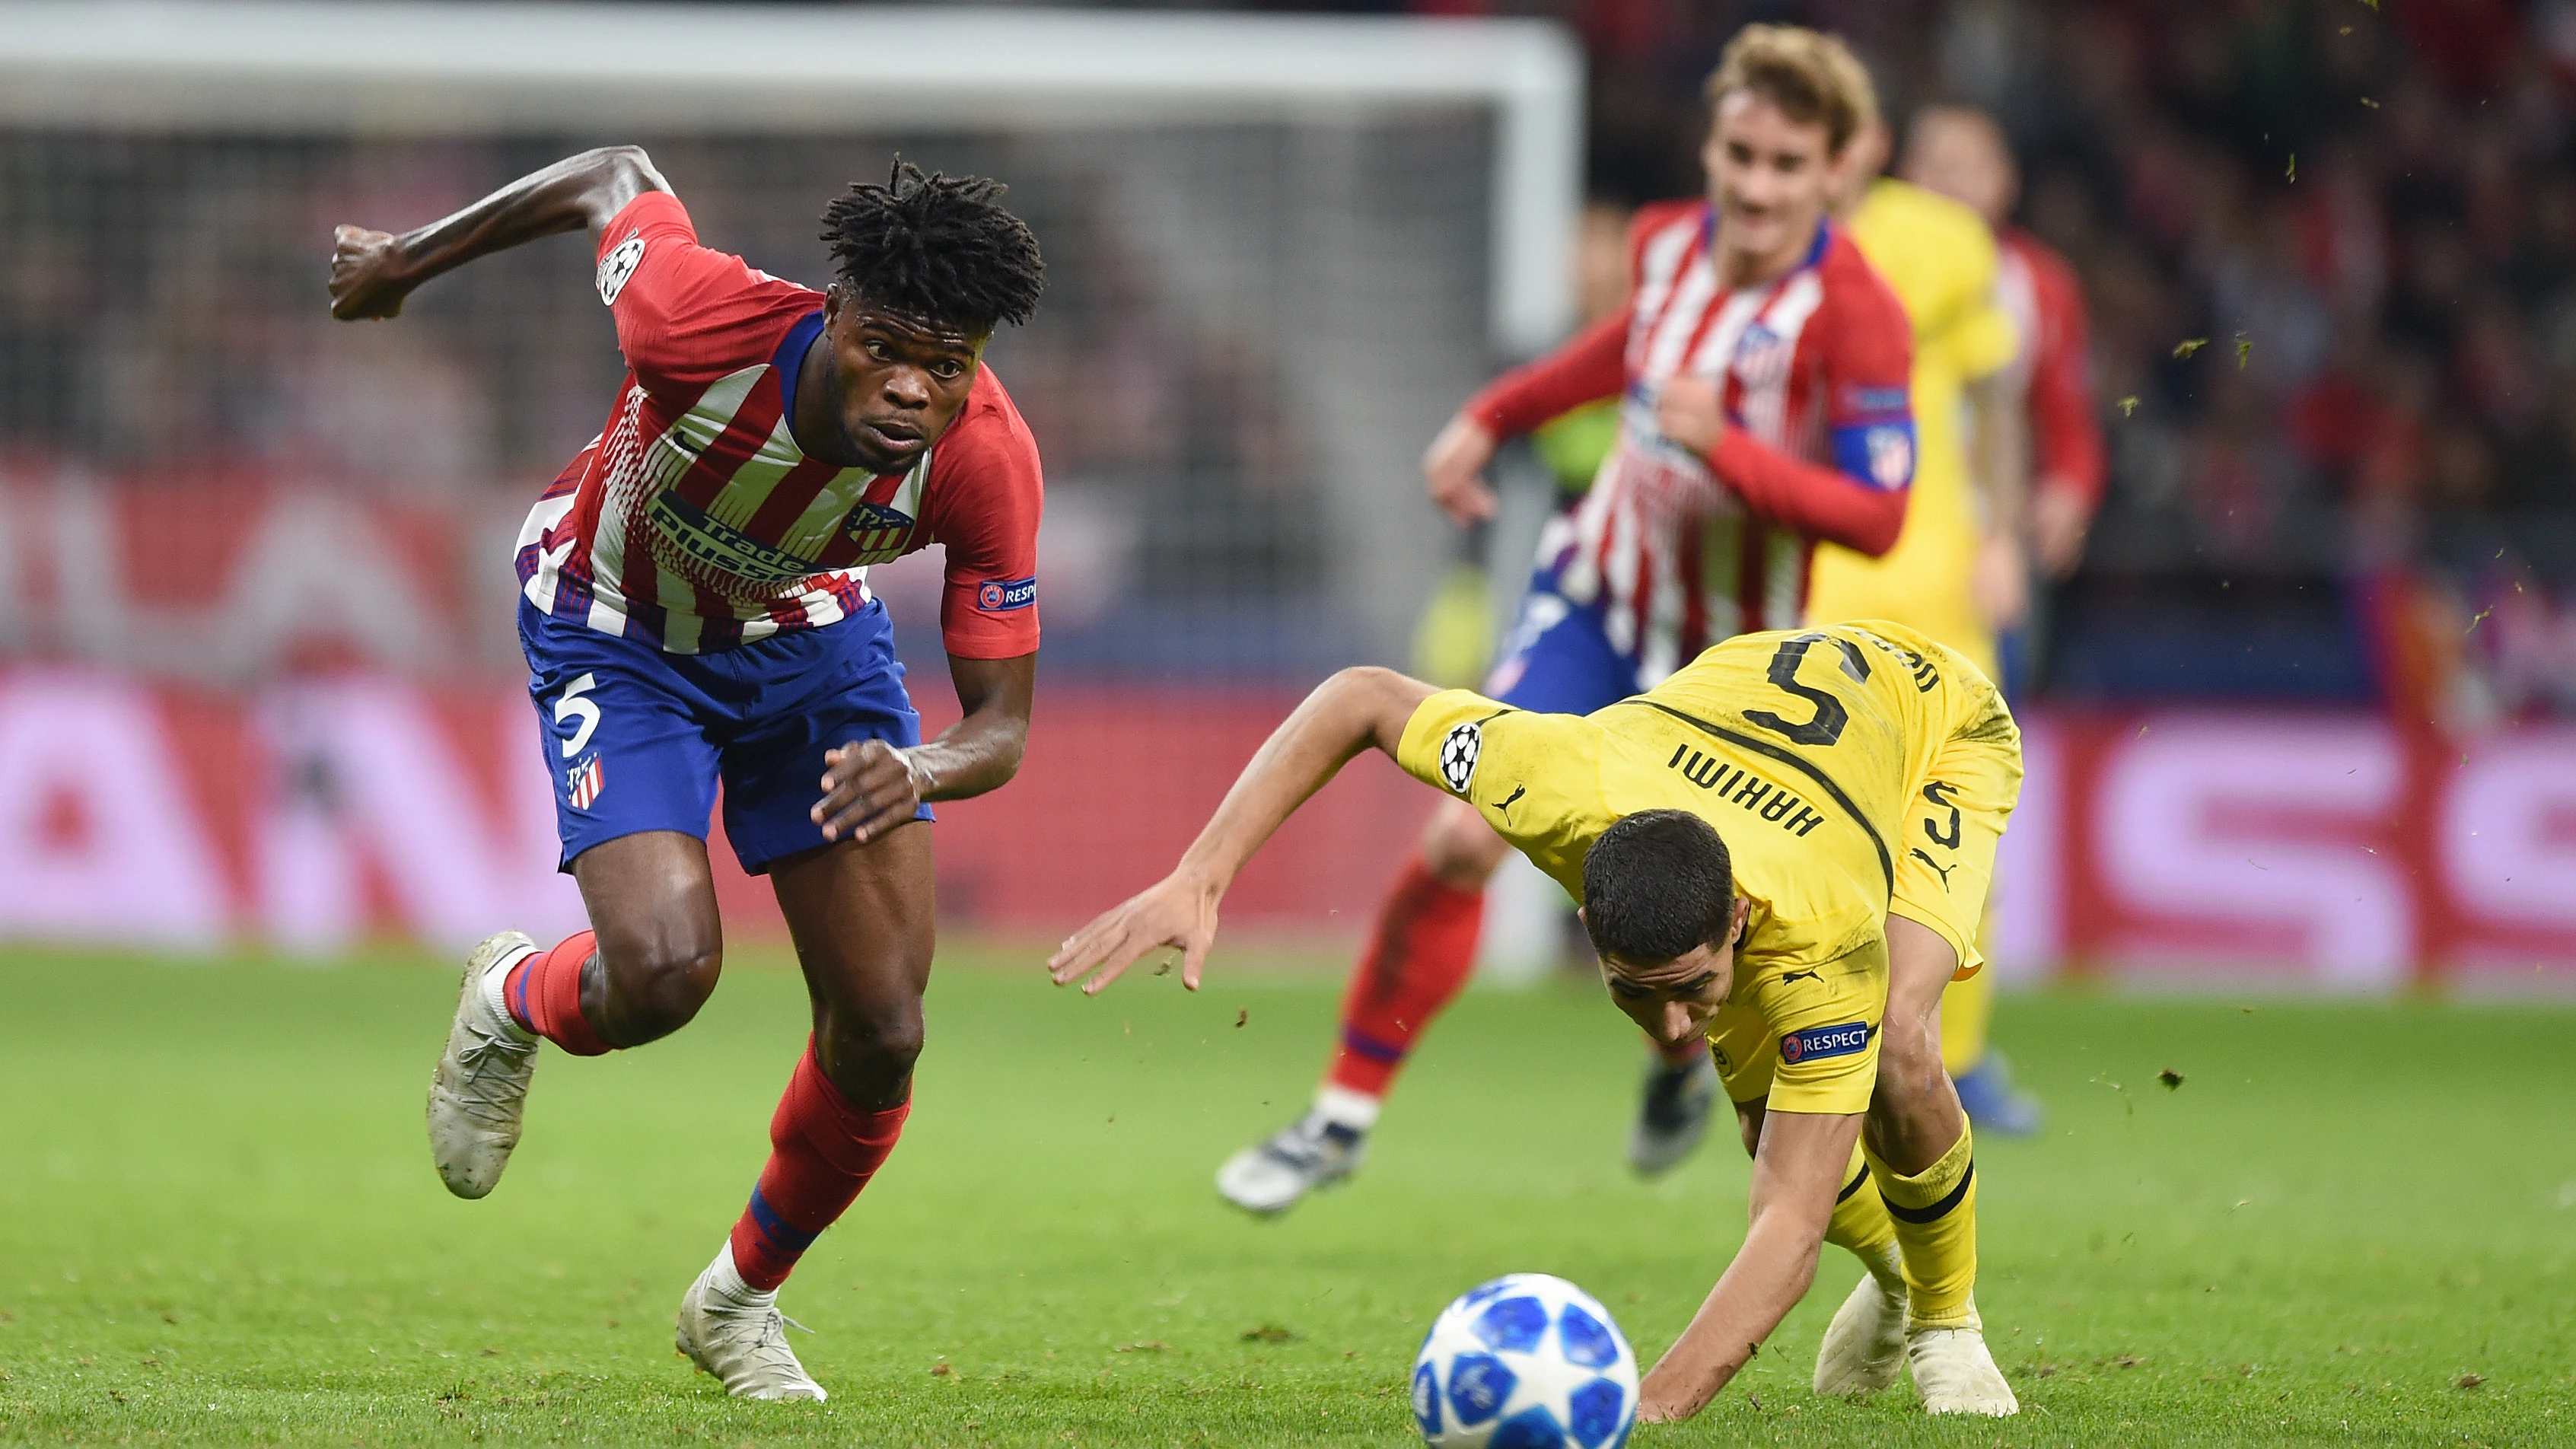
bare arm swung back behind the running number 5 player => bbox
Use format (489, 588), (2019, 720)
(330, 147), (670, 322)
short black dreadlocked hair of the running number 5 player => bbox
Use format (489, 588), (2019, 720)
(822, 158), (1046, 338)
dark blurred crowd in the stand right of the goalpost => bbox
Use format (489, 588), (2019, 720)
(1453, 0), (2576, 730)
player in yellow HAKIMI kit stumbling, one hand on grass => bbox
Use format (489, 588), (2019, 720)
(1049, 621), (2022, 1418)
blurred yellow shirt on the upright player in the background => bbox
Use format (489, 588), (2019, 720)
(1806, 178), (2020, 676)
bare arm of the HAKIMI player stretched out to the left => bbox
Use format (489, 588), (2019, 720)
(1046, 667), (1453, 989)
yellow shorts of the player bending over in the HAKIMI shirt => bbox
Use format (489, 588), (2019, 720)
(1888, 639), (2022, 977)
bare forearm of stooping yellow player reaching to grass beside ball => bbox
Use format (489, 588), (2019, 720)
(1638, 1111), (1860, 1423)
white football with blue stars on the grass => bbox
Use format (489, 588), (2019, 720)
(1414, 1274), (1635, 1449)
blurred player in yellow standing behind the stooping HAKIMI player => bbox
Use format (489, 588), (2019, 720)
(1808, 113), (2040, 1135)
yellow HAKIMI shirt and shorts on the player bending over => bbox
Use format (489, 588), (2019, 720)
(1396, 621), (2022, 1111)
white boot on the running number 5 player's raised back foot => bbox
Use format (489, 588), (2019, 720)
(430, 931), (536, 1196)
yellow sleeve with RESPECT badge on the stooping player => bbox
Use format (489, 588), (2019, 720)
(1708, 938), (1888, 1114)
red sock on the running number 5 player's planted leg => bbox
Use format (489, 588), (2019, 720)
(734, 1042), (912, 1291)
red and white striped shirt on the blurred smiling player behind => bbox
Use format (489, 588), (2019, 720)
(1468, 201), (1914, 689)
